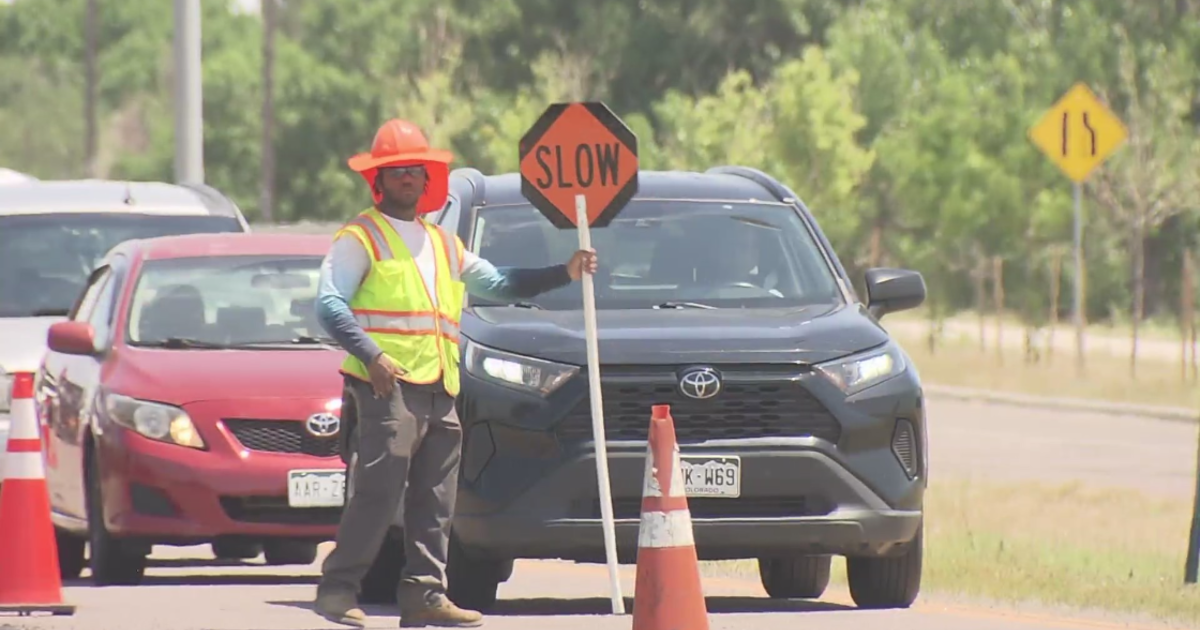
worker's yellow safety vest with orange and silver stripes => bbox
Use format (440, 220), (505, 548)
(334, 208), (466, 396)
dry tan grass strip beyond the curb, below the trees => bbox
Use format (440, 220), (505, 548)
(894, 328), (1200, 409)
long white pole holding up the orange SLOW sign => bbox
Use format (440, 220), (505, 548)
(575, 194), (625, 614)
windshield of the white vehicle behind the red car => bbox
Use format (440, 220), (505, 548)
(0, 212), (242, 317)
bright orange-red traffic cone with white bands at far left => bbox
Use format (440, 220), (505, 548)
(0, 372), (74, 614)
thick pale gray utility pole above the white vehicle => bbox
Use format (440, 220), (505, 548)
(174, 0), (204, 184)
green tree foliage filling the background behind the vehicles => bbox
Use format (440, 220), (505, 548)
(0, 0), (1200, 322)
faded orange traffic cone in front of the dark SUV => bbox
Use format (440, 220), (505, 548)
(634, 404), (708, 630)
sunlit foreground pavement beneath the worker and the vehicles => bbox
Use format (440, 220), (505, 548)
(0, 540), (1180, 630)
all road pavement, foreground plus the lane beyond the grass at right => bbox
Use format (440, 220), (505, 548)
(0, 400), (1196, 630)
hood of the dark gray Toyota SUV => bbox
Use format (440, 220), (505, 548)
(463, 305), (888, 365)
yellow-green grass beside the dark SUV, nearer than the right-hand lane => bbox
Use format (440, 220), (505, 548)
(703, 480), (1200, 628)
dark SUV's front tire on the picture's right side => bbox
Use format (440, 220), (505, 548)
(846, 526), (924, 608)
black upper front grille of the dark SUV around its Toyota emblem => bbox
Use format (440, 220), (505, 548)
(558, 367), (841, 443)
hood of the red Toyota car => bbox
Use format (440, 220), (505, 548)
(103, 347), (346, 404)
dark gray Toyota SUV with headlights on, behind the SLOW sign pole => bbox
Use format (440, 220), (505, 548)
(343, 162), (928, 610)
